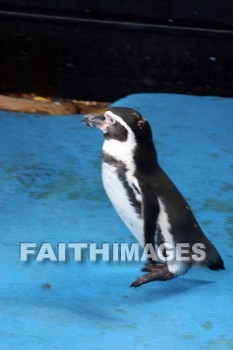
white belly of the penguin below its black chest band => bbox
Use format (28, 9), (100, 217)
(102, 161), (144, 246)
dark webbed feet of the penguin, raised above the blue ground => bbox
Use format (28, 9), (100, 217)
(131, 264), (176, 288)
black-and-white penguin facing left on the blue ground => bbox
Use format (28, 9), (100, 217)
(82, 107), (225, 287)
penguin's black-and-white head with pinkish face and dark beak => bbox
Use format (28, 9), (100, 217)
(82, 107), (152, 143)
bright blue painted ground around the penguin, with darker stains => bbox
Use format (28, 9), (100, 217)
(0, 94), (233, 350)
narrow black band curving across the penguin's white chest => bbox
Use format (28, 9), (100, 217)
(102, 152), (141, 217)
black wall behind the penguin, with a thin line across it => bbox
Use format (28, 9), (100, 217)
(0, 0), (233, 101)
